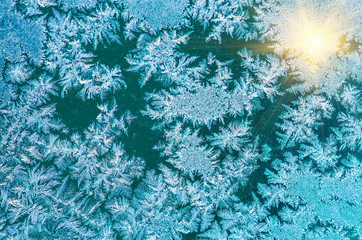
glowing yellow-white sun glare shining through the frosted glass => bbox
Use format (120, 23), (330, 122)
(279, 0), (346, 71)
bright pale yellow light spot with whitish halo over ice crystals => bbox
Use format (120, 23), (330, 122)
(271, 0), (350, 74)
